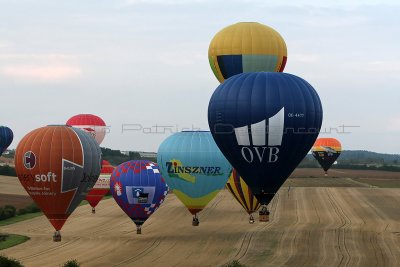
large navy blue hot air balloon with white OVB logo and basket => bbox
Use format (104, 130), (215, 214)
(208, 72), (322, 221)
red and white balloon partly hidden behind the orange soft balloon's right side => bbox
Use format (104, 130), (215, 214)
(86, 160), (114, 214)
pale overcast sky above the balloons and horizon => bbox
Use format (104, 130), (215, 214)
(0, 0), (400, 154)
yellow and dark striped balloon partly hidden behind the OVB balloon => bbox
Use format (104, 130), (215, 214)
(226, 169), (261, 223)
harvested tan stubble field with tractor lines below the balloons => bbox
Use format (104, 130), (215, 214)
(2, 188), (400, 267)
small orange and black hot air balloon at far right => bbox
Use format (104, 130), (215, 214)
(311, 138), (342, 176)
